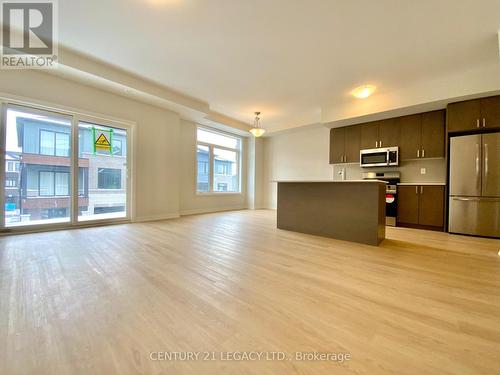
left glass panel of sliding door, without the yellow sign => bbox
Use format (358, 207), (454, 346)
(4, 106), (72, 227)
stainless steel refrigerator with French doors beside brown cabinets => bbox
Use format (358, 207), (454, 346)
(449, 133), (500, 237)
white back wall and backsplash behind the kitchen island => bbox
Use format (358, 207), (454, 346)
(263, 126), (446, 208)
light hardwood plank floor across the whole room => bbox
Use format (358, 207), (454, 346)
(0, 210), (500, 374)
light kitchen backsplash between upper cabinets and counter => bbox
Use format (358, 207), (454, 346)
(333, 158), (446, 182)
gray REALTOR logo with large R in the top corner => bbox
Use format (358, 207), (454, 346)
(0, 0), (58, 69)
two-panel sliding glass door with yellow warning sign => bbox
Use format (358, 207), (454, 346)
(0, 104), (129, 230)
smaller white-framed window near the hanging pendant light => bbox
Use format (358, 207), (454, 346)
(196, 127), (241, 193)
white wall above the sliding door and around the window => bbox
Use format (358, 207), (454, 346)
(0, 70), (247, 220)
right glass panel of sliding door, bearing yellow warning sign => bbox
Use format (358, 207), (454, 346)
(78, 122), (128, 221)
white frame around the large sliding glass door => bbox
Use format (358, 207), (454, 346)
(0, 98), (136, 235)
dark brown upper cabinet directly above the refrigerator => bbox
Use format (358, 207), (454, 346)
(447, 96), (500, 133)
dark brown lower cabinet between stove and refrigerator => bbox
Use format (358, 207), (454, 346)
(397, 185), (444, 230)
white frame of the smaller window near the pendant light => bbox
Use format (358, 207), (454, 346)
(194, 125), (243, 196)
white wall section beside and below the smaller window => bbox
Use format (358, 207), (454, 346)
(180, 120), (248, 215)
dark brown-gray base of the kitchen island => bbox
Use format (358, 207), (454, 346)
(278, 180), (385, 246)
